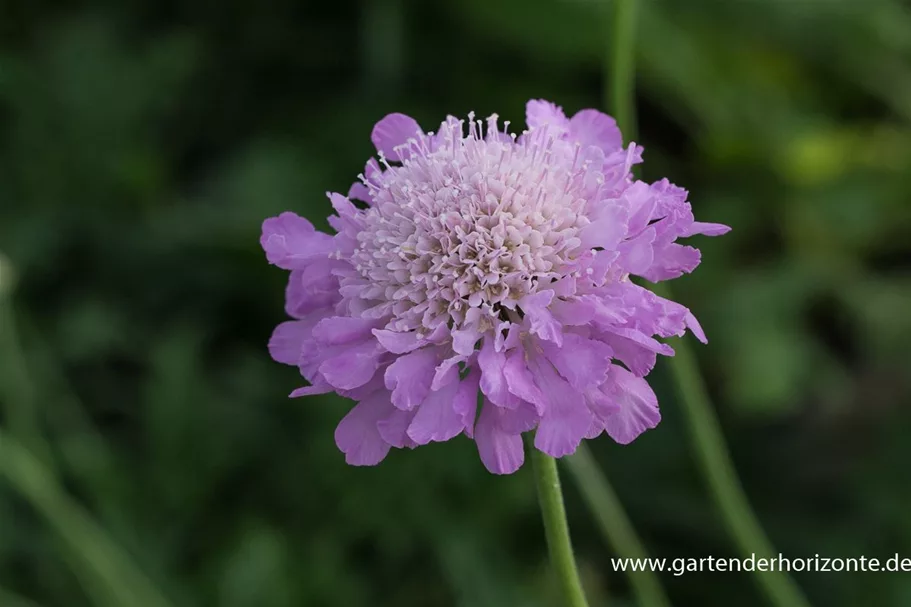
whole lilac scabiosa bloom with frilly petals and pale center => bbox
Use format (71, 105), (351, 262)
(261, 101), (729, 474)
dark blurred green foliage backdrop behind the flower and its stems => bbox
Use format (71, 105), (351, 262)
(0, 0), (911, 607)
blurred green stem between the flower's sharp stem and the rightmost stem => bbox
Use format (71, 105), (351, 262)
(563, 444), (671, 607)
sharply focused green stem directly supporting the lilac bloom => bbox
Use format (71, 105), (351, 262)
(530, 448), (588, 607)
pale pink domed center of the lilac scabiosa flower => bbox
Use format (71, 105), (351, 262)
(351, 116), (591, 333)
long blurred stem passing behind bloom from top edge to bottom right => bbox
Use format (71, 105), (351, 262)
(606, 0), (809, 607)
